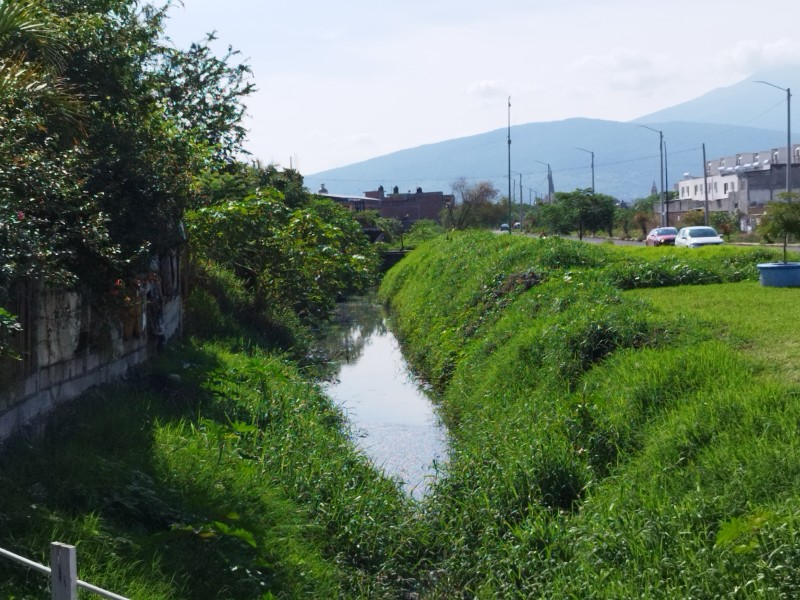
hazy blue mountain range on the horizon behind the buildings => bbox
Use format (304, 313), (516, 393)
(305, 68), (800, 202)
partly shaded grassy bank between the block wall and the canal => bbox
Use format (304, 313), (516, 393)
(0, 343), (415, 600)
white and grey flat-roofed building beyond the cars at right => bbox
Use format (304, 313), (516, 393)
(669, 144), (800, 232)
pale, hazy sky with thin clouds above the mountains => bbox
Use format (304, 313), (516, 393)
(166, 0), (800, 175)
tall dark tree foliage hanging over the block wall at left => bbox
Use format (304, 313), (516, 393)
(0, 0), (253, 350)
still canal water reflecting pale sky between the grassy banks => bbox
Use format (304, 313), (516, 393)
(318, 300), (447, 499)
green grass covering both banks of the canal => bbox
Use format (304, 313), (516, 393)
(0, 232), (800, 600)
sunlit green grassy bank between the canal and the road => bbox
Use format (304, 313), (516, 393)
(382, 234), (800, 598)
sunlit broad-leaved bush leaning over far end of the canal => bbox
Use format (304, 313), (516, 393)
(188, 178), (378, 321)
